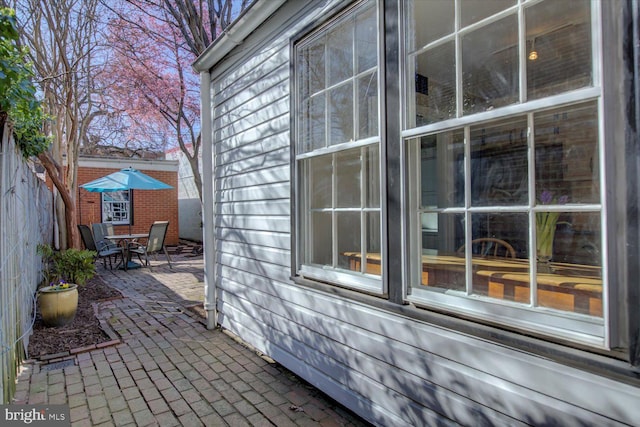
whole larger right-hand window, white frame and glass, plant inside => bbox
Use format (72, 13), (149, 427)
(403, 0), (608, 347)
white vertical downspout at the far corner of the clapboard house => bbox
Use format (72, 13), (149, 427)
(200, 71), (218, 329)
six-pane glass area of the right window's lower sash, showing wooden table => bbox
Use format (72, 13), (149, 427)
(408, 101), (602, 317)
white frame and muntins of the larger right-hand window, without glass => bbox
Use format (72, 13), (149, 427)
(401, 0), (616, 349)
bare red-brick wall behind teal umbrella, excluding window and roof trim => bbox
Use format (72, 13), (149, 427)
(76, 166), (178, 245)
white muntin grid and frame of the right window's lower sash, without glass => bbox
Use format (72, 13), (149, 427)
(404, 98), (610, 347)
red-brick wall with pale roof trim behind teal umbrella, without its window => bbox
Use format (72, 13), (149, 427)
(76, 158), (179, 245)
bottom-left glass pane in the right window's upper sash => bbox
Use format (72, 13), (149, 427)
(414, 42), (456, 126)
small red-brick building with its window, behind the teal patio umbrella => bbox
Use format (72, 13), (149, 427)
(76, 157), (179, 245)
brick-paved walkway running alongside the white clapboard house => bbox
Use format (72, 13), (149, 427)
(15, 254), (367, 427)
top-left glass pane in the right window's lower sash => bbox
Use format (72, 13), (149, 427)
(420, 130), (464, 208)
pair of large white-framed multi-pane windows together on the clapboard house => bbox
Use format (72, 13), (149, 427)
(293, 0), (633, 349)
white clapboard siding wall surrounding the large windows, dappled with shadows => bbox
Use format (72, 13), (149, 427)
(204, 1), (640, 426)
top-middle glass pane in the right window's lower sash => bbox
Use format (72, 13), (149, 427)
(471, 118), (529, 206)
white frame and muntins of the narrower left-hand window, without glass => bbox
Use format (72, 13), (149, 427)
(292, 0), (386, 295)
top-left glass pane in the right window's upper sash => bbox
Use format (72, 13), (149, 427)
(406, 0), (455, 52)
